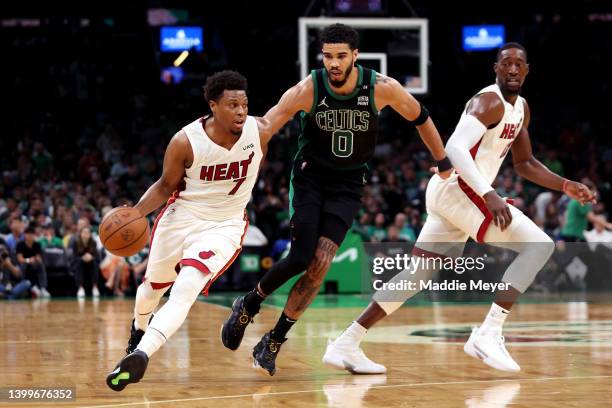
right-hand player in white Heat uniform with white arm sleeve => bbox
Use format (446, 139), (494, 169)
(323, 43), (595, 374)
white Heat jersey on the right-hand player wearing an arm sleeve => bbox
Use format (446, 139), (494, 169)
(463, 84), (525, 184)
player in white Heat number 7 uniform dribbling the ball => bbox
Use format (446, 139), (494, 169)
(106, 71), (282, 391)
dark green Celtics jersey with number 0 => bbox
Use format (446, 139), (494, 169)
(296, 65), (378, 170)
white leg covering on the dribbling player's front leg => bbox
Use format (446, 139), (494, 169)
(136, 266), (210, 357)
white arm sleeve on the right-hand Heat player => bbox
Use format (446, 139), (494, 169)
(446, 115), (493, 197)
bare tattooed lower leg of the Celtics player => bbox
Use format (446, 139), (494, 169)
(285, 237), (338, 320)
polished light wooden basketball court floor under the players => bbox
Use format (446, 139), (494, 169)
(0, 297), (612, 408)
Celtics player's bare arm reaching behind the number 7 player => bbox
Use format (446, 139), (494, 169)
(257, 76), (314, 146)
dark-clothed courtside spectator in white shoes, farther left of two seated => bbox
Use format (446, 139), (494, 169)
(16, 226), (51, 298)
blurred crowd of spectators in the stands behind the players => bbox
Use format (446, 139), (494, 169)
(0, 108), (612, 298)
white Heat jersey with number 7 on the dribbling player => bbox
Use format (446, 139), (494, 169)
(176, 116), (263, 221)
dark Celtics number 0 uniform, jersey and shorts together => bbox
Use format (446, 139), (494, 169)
(290, 66), (378, 244)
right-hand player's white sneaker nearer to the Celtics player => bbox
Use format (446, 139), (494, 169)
(323, 340), (387, 374)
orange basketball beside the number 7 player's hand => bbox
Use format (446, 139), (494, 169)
(99, 207), (149, 256)
